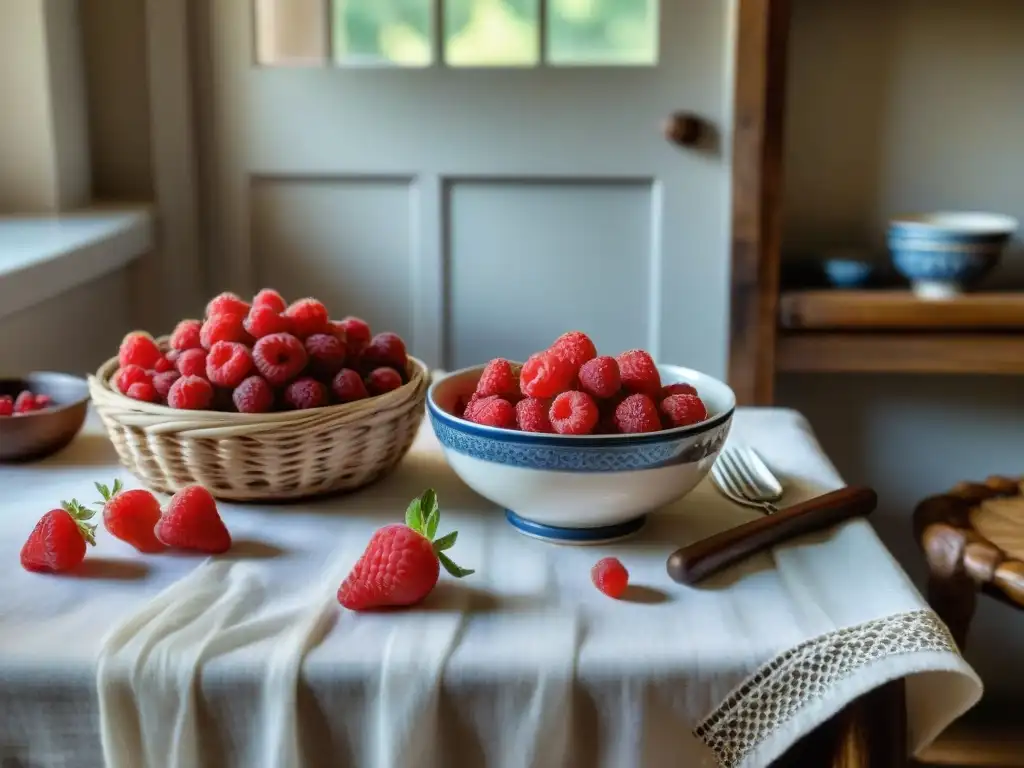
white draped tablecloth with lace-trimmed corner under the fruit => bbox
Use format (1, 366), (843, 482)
(0, 410), (981, 768)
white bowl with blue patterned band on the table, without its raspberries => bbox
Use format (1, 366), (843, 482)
(427, 366), (736, 544)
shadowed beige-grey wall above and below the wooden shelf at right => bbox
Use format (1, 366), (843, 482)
(777, 0), (1024, 696)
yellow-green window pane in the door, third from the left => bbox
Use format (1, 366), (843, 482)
(444, 0), (541, 67)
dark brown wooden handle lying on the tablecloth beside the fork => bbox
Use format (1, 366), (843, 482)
(668, 487), (879, 584)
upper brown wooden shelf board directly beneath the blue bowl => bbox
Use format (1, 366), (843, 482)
(779, 291), (1024, 332)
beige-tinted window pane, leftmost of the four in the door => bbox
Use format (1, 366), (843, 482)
(255, 0), (327, 67)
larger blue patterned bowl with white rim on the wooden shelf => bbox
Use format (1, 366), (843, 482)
(888, 212), (1018, 299)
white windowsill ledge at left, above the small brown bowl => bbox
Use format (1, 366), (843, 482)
(0, 205), (154, 316)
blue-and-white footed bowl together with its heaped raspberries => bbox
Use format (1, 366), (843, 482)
(427, 331), (736, 544)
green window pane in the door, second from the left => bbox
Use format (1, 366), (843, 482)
(332, 0), (432, 67)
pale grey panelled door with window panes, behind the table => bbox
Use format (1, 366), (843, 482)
(199, 0), (733, 376)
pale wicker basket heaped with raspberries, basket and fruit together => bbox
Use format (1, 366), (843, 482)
(83, 289), (429, 501)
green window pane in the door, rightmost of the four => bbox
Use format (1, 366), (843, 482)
(548, 0), (659, 65)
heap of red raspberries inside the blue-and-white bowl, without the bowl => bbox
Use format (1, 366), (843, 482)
(456, 331), (708, 435)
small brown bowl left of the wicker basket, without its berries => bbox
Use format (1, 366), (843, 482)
(0, 372), (89, 462)
